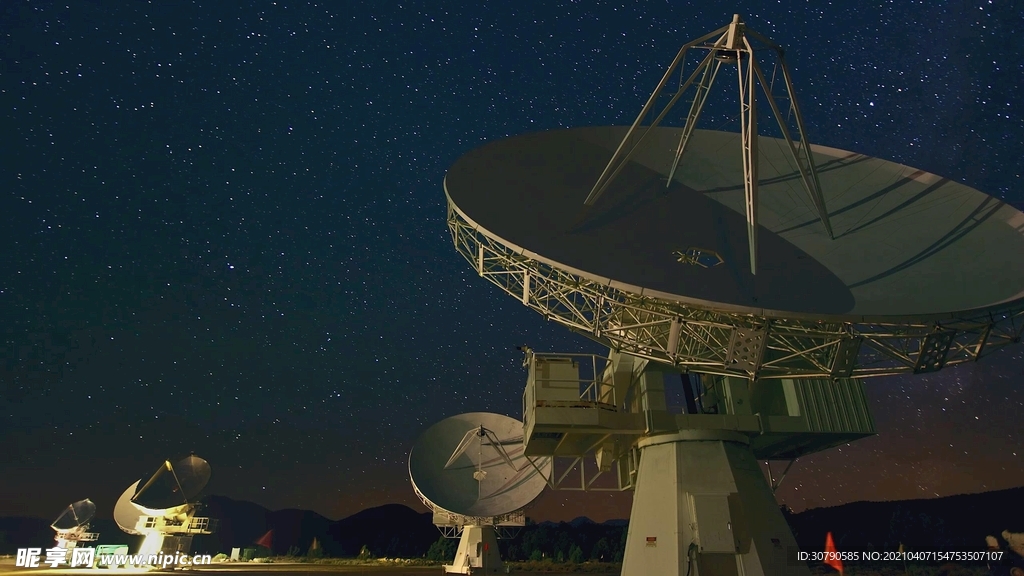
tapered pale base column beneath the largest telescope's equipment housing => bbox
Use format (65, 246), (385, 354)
(622, 429), (810, 576)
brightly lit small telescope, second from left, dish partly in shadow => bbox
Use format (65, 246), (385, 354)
(114, 454), (216, 557)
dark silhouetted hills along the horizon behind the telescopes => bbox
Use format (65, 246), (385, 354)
(0, 487), (1024, 560)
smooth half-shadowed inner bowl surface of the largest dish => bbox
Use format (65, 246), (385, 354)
(444, 126), (1024, 321)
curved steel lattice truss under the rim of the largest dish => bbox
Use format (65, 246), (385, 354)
(447, 198), (1024, 378)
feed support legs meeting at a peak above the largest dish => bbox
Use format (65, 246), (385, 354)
(584, 14), (836, 275)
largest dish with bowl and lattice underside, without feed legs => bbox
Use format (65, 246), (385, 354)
(444, 126), (1024, 378)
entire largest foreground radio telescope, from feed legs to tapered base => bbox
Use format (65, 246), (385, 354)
(444, 15), (1024, 576)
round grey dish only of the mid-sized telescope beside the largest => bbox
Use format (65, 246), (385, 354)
(409, 412), (551, 524)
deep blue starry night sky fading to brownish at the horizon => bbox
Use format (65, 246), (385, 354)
(0, 0), (1024, 520)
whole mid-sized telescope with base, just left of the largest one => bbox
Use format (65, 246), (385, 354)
(409, 412), (551, 574)
